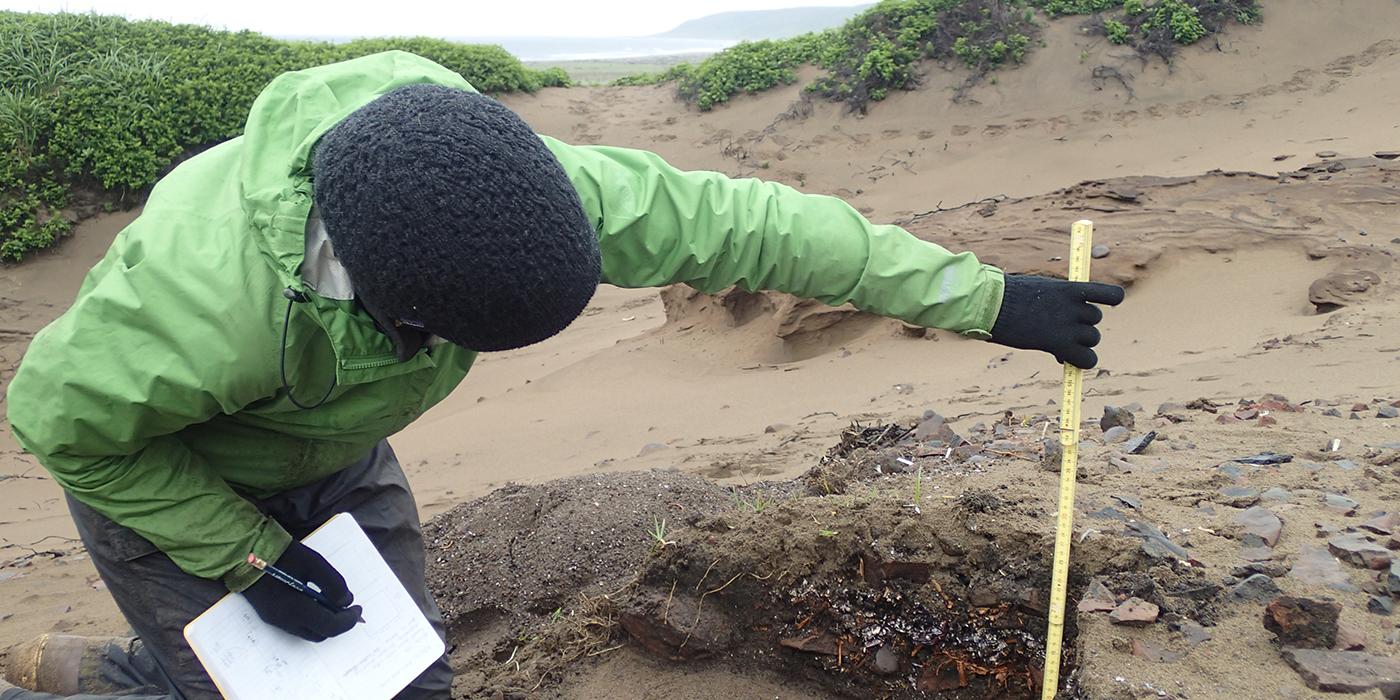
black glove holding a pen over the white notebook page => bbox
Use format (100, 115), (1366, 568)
(244, 542), (361, 641)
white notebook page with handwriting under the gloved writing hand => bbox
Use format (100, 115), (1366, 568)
(185, 514), (444, 700)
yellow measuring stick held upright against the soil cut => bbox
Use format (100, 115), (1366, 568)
(1040, 221), (1093, 700)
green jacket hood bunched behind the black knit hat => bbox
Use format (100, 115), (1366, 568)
(238, 50), (475, 291)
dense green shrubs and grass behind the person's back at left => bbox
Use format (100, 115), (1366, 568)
(0, 11), (557, 260)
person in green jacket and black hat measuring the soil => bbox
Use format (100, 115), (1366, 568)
(0, 52), (1123, 700)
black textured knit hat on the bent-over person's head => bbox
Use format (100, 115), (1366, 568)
(311, 85), (602, 350)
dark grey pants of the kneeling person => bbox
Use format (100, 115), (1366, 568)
(0, 442), (452, 700)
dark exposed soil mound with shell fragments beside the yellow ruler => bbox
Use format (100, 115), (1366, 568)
(426, 424), (1215, 699)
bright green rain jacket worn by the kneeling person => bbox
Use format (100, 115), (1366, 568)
(8, 52), (1002, 591)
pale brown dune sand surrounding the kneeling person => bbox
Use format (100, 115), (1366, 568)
(0, 0), (1400, 699)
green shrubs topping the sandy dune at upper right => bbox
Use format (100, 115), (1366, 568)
(624, 0), (1259, 111)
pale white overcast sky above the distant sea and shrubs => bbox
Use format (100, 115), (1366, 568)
(0, 0), (862, 36)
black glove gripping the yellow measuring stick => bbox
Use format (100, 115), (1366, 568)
(991, 274), (1123, 370)
